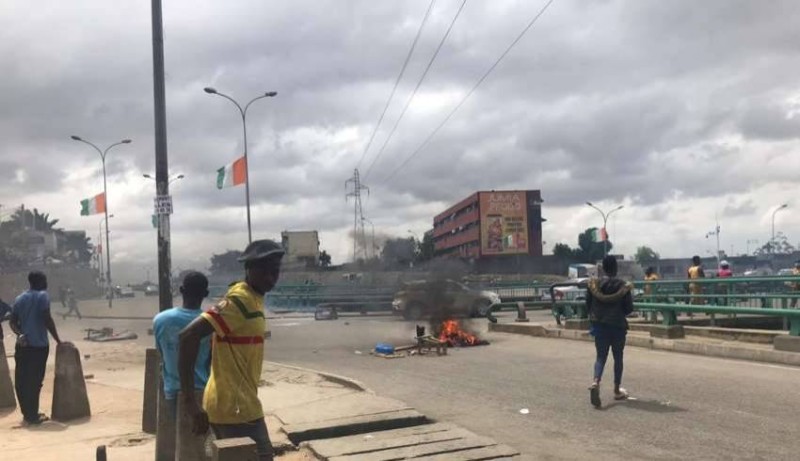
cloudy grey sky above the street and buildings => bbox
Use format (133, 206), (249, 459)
(0, 0), (800, 281)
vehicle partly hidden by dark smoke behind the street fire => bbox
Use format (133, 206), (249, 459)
(392, 279), (500, 320)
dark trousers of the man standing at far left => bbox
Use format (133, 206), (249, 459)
(14, 346), (50, 422)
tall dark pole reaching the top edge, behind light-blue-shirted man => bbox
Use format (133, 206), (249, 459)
(152, 0), (172, 311)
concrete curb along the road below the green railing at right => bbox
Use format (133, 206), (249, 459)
(489, 323), (800, 366)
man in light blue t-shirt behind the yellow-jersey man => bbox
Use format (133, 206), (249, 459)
(153, 272), (211, 416)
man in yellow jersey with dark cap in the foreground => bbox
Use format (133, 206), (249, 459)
(178, 240), (284, 461)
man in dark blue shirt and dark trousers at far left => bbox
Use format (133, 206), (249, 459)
(11, 271), (61, 425)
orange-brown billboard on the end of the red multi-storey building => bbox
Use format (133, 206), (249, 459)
(479, 191), (529, 255)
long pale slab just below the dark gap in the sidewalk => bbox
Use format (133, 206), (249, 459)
(308, 428), (475, 459)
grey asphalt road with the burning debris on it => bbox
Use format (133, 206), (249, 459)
(266, 313), (800, 460)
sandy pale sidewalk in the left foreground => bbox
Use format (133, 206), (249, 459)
(0, 328), (518, 461)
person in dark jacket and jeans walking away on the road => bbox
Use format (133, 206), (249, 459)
(586, 256), (633, 409)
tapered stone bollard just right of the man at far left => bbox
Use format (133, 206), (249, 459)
(52, 343), (92, 421)
